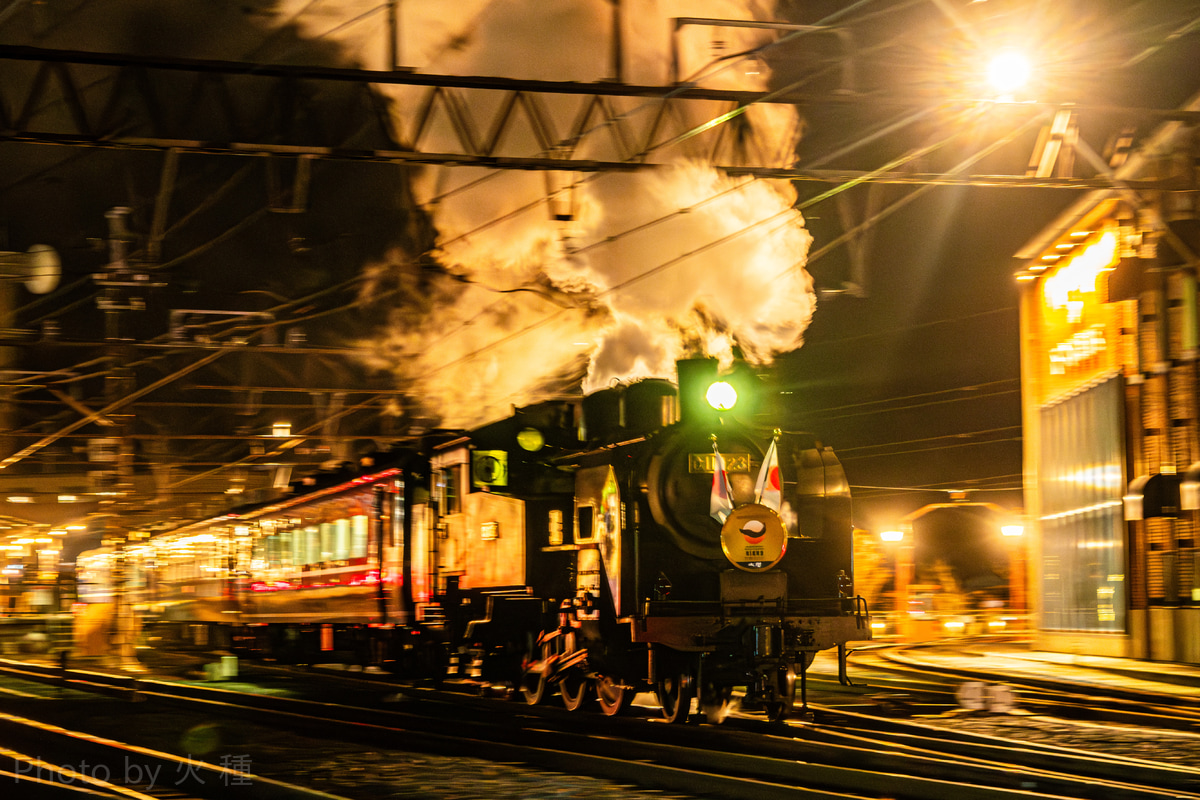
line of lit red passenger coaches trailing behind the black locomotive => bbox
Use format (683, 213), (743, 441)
(80, 449), (431, 663)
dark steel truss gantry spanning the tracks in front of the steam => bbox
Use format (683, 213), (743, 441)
(0, 46), (1194, 193)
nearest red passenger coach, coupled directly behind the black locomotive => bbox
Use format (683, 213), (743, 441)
(224, 450), (430, 663)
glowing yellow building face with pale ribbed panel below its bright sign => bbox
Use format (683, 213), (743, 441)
(1022, 211), (1136, 633)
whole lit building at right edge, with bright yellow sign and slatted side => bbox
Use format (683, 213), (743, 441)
(1016, 96), (1200, 663)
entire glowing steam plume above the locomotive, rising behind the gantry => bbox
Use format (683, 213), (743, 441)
(284, 0), (815, 425)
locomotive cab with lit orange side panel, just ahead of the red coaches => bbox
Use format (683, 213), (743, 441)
(432, 403), (578, 684)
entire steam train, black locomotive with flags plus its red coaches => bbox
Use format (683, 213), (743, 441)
(79, 360), (871, 722)
